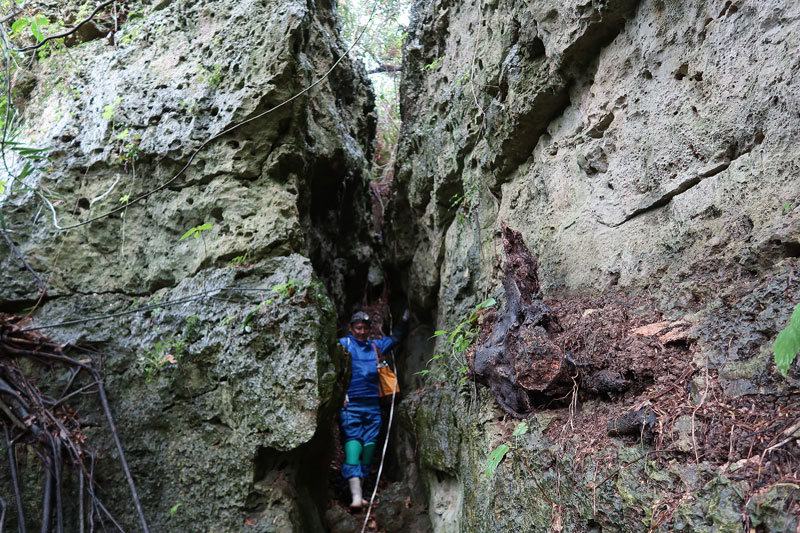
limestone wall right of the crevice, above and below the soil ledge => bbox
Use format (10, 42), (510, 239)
(391, 0), (800, 531)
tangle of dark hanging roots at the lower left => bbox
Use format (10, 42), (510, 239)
(0, 315), (148, 533)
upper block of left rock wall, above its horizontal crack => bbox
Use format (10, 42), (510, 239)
(0, 0), (374, 305)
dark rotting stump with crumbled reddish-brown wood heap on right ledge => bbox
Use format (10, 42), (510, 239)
(468, 224), (689, 420)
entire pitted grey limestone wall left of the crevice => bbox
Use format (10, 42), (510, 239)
(0, 0), (375, 531)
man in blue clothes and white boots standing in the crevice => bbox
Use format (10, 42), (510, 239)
(339, 309), (409, 509)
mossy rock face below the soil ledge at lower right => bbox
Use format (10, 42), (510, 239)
(405, 389), (797, 532)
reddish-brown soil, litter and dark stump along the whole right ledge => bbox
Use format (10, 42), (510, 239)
(467, 226), (800, 524)
